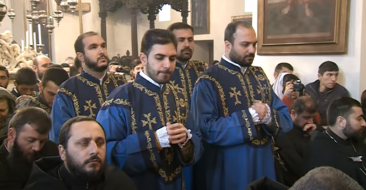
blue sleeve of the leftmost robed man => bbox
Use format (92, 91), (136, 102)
(49, 90), (76, 143)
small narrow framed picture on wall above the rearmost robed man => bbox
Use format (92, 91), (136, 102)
(191, 0), (210, 34)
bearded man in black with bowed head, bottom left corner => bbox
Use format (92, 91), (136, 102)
(0, 107), (58, 190)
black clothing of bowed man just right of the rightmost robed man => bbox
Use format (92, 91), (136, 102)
(275, 126), (310, 186)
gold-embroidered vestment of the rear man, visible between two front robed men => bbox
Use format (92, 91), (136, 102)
(170, 60), (206, 101)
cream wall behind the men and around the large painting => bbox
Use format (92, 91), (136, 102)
(43, 0), (366, 99)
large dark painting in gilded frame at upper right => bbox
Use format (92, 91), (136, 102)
(257, 0), (349, 55)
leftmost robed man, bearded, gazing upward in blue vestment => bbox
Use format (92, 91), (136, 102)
(50, 32), (126, 142)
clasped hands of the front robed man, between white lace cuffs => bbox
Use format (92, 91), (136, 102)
(166, 123), (187, 144)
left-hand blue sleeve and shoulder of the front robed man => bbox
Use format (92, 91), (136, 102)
(97, 82), (161, 175)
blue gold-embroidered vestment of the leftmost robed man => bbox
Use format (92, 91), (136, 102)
(50, 70), (126, 143)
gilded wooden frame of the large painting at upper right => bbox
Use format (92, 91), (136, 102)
(257, 0), (350, 55)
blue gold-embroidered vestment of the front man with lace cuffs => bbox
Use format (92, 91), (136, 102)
(97, 74), (202, 190)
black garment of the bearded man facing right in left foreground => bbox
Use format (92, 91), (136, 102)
(24, 157), (136, 190)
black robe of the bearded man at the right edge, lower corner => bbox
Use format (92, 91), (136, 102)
(304, 129), (366, 188)
